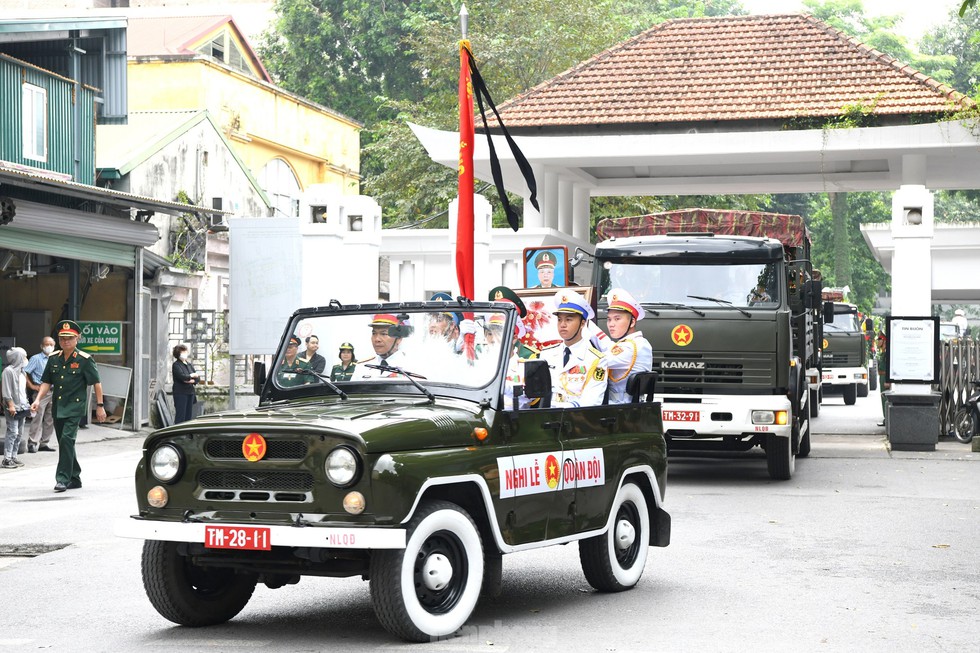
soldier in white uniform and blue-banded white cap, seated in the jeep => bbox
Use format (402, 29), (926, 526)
(541, 289), (606, 407)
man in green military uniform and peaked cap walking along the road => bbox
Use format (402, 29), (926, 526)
(31, 320), (105, 492)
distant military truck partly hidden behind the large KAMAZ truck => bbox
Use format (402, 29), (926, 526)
(820, 288), (873, 406)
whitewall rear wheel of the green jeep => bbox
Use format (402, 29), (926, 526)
(578, 483), (650, 592)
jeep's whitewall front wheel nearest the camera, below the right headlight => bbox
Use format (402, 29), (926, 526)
(370, 501), (483, 642)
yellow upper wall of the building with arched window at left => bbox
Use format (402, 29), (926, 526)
(127, 59), (361, 195)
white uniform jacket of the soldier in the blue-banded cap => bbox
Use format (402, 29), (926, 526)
(541, 338), (607, 407)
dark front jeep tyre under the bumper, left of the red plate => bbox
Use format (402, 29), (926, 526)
(142, 540), (256, 626)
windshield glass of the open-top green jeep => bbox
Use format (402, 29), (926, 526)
(269, 303), (509, 394)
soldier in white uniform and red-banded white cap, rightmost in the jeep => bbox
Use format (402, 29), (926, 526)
(599, 288), (653, 404)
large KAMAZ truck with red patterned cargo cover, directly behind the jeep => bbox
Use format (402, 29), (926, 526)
(593, 209), (822, 480)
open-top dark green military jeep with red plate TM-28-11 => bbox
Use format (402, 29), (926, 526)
(117, 302), (670, 641)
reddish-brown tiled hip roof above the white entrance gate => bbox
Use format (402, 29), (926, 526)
(500, 14), (970, 134)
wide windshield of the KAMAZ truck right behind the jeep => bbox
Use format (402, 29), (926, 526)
(599, 260), (780, 310)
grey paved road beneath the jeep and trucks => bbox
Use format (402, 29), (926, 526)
(0, 394), (980, 653)
